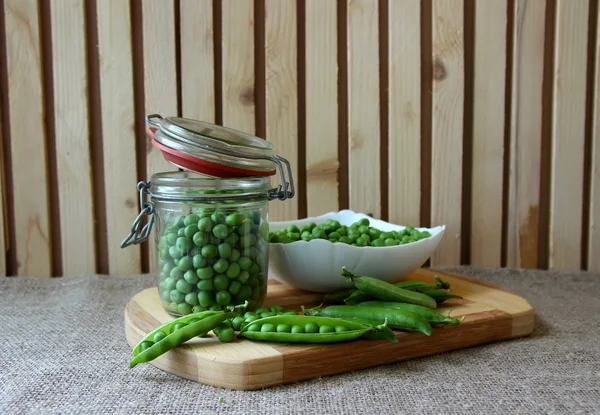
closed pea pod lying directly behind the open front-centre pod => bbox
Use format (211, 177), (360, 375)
(304, 305), (431, 336)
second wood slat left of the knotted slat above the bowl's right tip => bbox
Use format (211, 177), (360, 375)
(347, 0), (381, 218)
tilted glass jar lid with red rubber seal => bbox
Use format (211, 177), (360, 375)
(146, 114), (277, 177)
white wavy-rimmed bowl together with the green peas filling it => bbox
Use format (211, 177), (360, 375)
(269, 210), (446, 293)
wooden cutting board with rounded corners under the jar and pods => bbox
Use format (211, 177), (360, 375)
(125, 269), (534, 389)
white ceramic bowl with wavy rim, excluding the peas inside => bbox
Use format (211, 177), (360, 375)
(269, 210), (446, 293)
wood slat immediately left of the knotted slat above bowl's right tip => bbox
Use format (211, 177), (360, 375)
(382, 0), (421, 226)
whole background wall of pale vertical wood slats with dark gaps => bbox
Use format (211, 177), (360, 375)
(0, 0), (600, 277)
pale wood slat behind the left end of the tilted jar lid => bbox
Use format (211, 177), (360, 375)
(142, 1), (178, 272)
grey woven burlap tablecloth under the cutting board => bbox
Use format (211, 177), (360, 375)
(0, 268), (600, 414)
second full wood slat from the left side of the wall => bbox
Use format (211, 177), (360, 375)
(50, 0), (96, 276)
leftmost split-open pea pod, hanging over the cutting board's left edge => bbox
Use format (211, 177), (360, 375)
(129, 311), (227, 368)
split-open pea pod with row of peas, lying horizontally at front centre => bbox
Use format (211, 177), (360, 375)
(238, 315), (387, 344)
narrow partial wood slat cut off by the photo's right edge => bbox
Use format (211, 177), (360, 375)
(587, 17), (600, 272)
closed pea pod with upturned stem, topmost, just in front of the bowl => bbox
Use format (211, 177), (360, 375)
(342, 267), (437, 309)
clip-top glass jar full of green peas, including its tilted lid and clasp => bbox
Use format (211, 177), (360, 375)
(121, 115), (294, 316)
